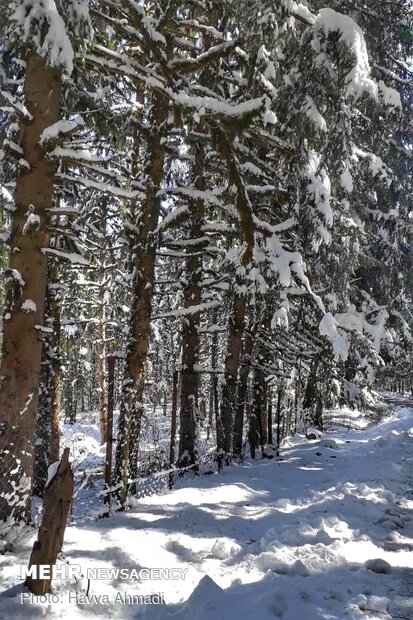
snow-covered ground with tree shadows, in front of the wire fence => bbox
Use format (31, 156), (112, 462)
(0, 408), (413, 620)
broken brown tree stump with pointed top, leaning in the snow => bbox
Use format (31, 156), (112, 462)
(25, 448), (73, 596)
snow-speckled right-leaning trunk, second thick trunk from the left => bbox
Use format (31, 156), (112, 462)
(115, 93), (168, 504)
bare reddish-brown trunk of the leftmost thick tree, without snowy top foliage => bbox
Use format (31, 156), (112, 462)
(0, 52), (61, 520)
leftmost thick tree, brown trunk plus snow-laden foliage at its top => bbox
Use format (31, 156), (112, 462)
(0, 0), (90, 519)
